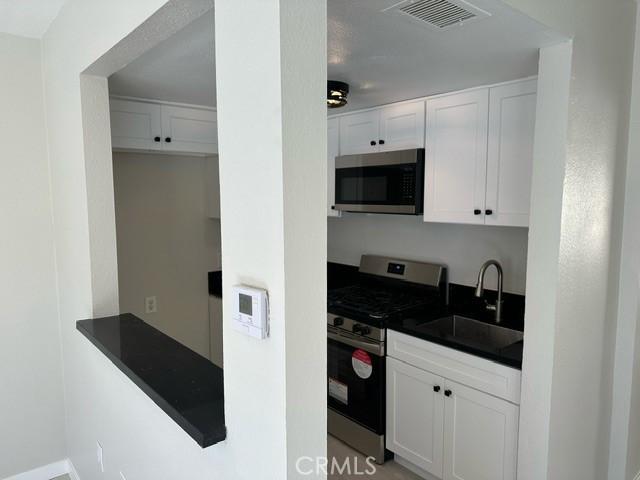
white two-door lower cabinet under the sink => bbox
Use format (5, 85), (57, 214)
(386, 331), (520, 480)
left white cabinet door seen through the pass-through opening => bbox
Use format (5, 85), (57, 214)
(109, 99), (162, 150)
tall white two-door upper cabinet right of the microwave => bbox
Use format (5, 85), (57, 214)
(424, 79), (537, 227)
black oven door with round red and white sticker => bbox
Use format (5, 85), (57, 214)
(327, 328), (385, 434)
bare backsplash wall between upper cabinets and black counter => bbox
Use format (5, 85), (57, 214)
(328, 213), (528, 294)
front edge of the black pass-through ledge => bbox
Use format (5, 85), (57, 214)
(76, 320), (227, 448)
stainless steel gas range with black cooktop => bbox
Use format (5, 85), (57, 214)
(327, 255), (446, 463)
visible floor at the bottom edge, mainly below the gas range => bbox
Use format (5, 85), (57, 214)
(51, 436), (422, 480)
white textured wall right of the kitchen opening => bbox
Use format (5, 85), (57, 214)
(507, 0), (635, 480)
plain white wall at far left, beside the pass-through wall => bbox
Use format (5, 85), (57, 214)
(0, 34), (65, 478)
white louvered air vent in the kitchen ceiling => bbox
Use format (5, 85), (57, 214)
(387, 0), (490, 30)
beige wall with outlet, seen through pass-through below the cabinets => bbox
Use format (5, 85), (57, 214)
(113, 153), (220, 358)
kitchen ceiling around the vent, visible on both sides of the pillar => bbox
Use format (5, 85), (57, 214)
(109, 0), (560, 112)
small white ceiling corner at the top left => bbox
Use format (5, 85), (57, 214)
(0, 0), (66, 38)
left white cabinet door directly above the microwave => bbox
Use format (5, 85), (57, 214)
(340, 110), (380, 155)
